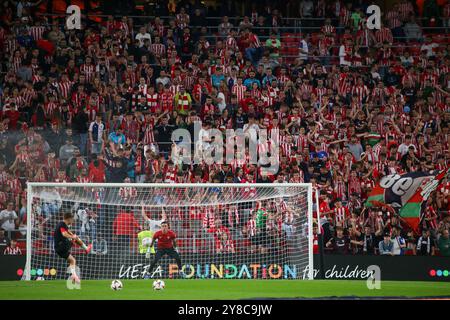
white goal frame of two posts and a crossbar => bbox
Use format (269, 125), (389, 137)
(24, 182), (314, 281)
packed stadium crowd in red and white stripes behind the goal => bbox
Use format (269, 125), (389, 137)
(0, 0), (450, 256)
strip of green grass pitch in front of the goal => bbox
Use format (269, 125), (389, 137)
(0, 280), (450, 300)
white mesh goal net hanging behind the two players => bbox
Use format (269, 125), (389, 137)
(24, 183), (313, 280)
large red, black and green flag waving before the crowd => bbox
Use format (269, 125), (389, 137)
(365, 168), (450, 230)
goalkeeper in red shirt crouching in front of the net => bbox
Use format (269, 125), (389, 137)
(146, 221), (184, 277)
